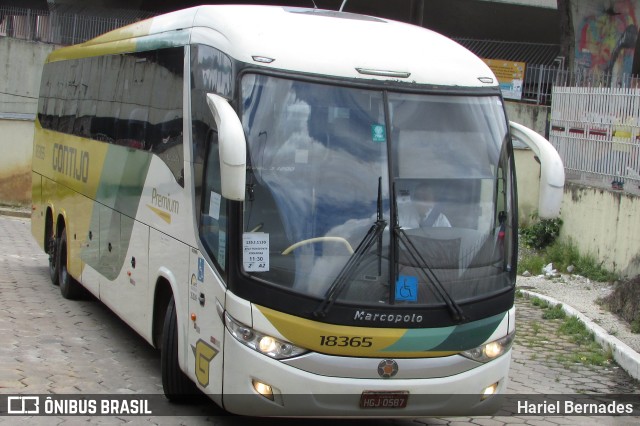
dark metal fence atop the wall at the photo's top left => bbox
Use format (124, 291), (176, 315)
(0, 7), (149, 45)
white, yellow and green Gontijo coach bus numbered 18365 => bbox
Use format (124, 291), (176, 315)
(32, 6), (563, 417)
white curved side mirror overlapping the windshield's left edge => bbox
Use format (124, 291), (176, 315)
(207, 93), (247, 201)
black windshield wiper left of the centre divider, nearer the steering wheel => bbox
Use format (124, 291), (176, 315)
(313, 177), (387, 318)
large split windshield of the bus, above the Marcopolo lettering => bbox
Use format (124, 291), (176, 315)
(241, 74), (515, 307)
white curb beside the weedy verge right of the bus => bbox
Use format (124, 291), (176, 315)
(520, 290), (640, 380)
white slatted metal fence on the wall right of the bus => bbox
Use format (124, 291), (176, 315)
(549, 86), (640, 194)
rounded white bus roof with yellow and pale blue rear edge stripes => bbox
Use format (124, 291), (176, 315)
(49, 5), (498, 87)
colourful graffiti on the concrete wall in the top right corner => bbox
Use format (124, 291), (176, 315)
(573, 0), (640, 81)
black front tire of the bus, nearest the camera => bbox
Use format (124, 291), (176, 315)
(160, 296), (199, 403)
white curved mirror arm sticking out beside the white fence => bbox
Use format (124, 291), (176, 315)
(509, 121), (564, 219)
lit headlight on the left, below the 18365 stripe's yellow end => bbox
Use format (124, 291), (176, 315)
(224, 314), (308, 359)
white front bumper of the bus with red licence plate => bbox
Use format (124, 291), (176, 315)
(218, 332), (511, 418)
